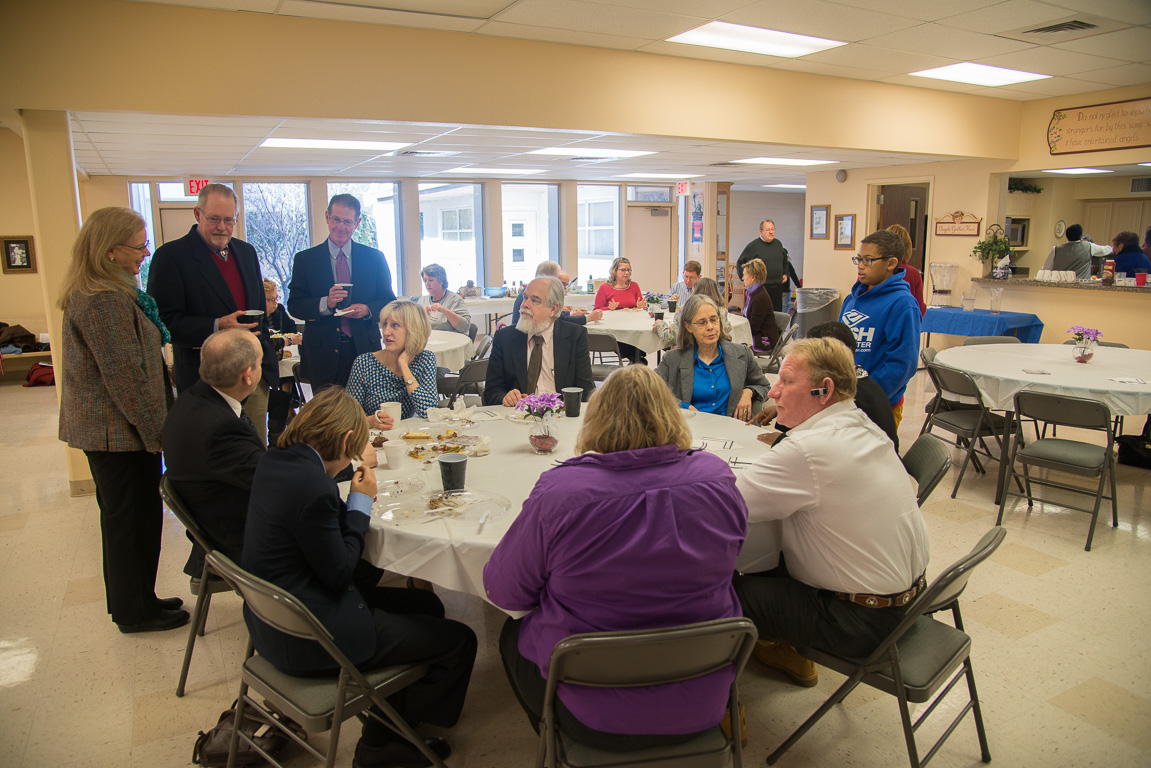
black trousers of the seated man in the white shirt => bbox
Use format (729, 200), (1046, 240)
(733, 567), (906, 656)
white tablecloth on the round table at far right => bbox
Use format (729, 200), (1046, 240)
(936, 344), (1151, 416)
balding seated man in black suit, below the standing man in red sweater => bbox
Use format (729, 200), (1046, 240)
(160, 328), (264, 578)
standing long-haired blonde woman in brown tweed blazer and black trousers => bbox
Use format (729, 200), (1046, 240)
(59, 207), (188, 633)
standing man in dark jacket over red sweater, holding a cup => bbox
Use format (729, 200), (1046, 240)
(147, 184), (280, 439)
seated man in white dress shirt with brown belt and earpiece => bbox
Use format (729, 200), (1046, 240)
(735, 339), (929, 686)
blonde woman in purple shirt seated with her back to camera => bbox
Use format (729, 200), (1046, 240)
(483, 365), (747, 751)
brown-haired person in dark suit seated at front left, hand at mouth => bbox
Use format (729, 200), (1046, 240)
(242, 387), (475, 768)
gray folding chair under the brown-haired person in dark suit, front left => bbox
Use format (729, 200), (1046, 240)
(208, 552), (445, 768)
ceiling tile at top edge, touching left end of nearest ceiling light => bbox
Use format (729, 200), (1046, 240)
(497, 0), (700, 40)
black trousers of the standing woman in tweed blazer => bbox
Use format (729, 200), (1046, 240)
(84, 450), (163, 624)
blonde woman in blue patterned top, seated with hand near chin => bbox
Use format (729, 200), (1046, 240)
(348, 299), (439, 429)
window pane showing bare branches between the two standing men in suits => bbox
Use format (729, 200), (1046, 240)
(241, 182), (312, 297)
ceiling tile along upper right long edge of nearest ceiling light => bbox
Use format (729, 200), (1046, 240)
(723, 0), (916, 43)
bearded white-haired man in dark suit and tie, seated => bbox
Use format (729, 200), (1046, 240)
(483, 277), (595, 405)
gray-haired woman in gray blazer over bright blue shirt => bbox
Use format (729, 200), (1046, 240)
(656, 294), (770, 421)
